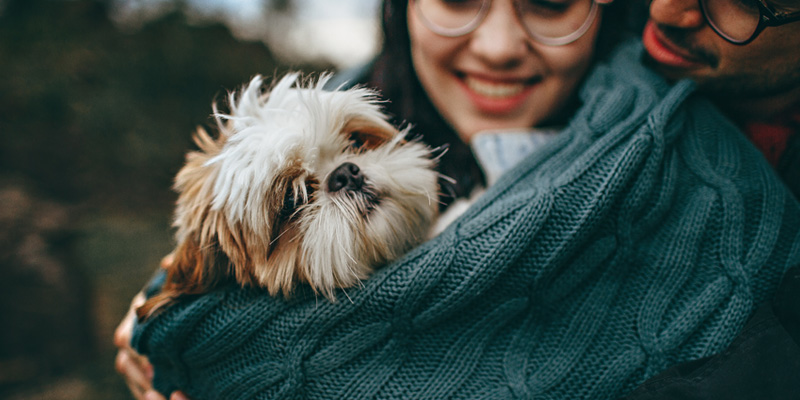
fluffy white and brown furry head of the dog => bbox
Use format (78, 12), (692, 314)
(139, 74), (438, 318)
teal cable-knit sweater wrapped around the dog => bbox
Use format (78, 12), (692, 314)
(133, 43), (800, 399)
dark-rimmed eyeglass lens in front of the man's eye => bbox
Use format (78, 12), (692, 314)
(700, 0), (761, 42)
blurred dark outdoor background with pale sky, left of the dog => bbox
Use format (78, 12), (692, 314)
(0, 0), (380, 400)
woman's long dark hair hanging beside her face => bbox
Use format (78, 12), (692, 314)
(366, 0), (624, 208)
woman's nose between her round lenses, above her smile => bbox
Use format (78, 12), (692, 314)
(470, 0), (530, 67)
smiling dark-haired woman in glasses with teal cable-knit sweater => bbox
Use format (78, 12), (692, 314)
(120, 0), (800, 398)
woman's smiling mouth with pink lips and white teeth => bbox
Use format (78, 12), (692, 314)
(460, 75), (538, 114)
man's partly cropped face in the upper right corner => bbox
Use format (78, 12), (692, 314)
(643, 0), (800, 102)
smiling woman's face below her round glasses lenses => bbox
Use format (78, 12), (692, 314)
(408, 0), (599, 142)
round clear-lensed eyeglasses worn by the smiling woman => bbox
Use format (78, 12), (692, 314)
(411, 0), (599, 46)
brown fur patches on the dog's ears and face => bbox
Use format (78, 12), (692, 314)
(137, 79), (434, 320)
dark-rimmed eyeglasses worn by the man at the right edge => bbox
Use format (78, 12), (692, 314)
(700, 0), (800, 45)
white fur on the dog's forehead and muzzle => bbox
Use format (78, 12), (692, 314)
(198, 74), (438, 297)
